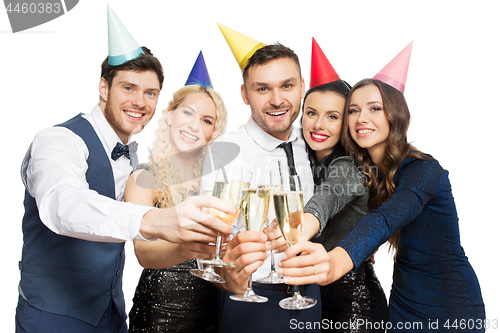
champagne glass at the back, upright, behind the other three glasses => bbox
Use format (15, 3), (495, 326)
(257, 159), (283, 284)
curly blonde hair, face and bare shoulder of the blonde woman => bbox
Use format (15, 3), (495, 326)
(139, 84), (227, 207)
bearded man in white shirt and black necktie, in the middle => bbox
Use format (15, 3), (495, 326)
(201, 28), (321, 332)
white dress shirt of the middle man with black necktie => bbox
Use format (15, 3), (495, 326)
(200, 117), (314, 281)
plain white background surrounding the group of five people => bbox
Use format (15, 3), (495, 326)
(0, 0), (500, 331)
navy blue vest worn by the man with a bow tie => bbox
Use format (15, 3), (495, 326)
(19, 115), (125, 326)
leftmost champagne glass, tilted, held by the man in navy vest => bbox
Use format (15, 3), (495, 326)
(189, 165), (251, 283)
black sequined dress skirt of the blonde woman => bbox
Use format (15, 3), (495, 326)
(129, 164), (217, 333)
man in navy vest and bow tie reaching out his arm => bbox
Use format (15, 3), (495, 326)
(16, 6), (235, 333)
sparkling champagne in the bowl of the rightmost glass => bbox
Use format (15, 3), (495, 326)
(273, 192), (304, 245)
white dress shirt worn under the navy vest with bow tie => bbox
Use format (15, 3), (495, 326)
(26, 106), (152, 242)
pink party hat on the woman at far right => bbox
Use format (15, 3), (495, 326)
(373, 41), (413, 93)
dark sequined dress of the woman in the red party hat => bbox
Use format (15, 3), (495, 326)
(304, 156), (387, 332)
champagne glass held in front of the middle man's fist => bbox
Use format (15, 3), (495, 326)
(229, 165), (271, 303)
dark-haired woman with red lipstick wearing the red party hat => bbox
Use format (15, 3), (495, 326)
(284, 39), (387, 332)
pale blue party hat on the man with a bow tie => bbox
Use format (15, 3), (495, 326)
(108, 5), (144, 66)
